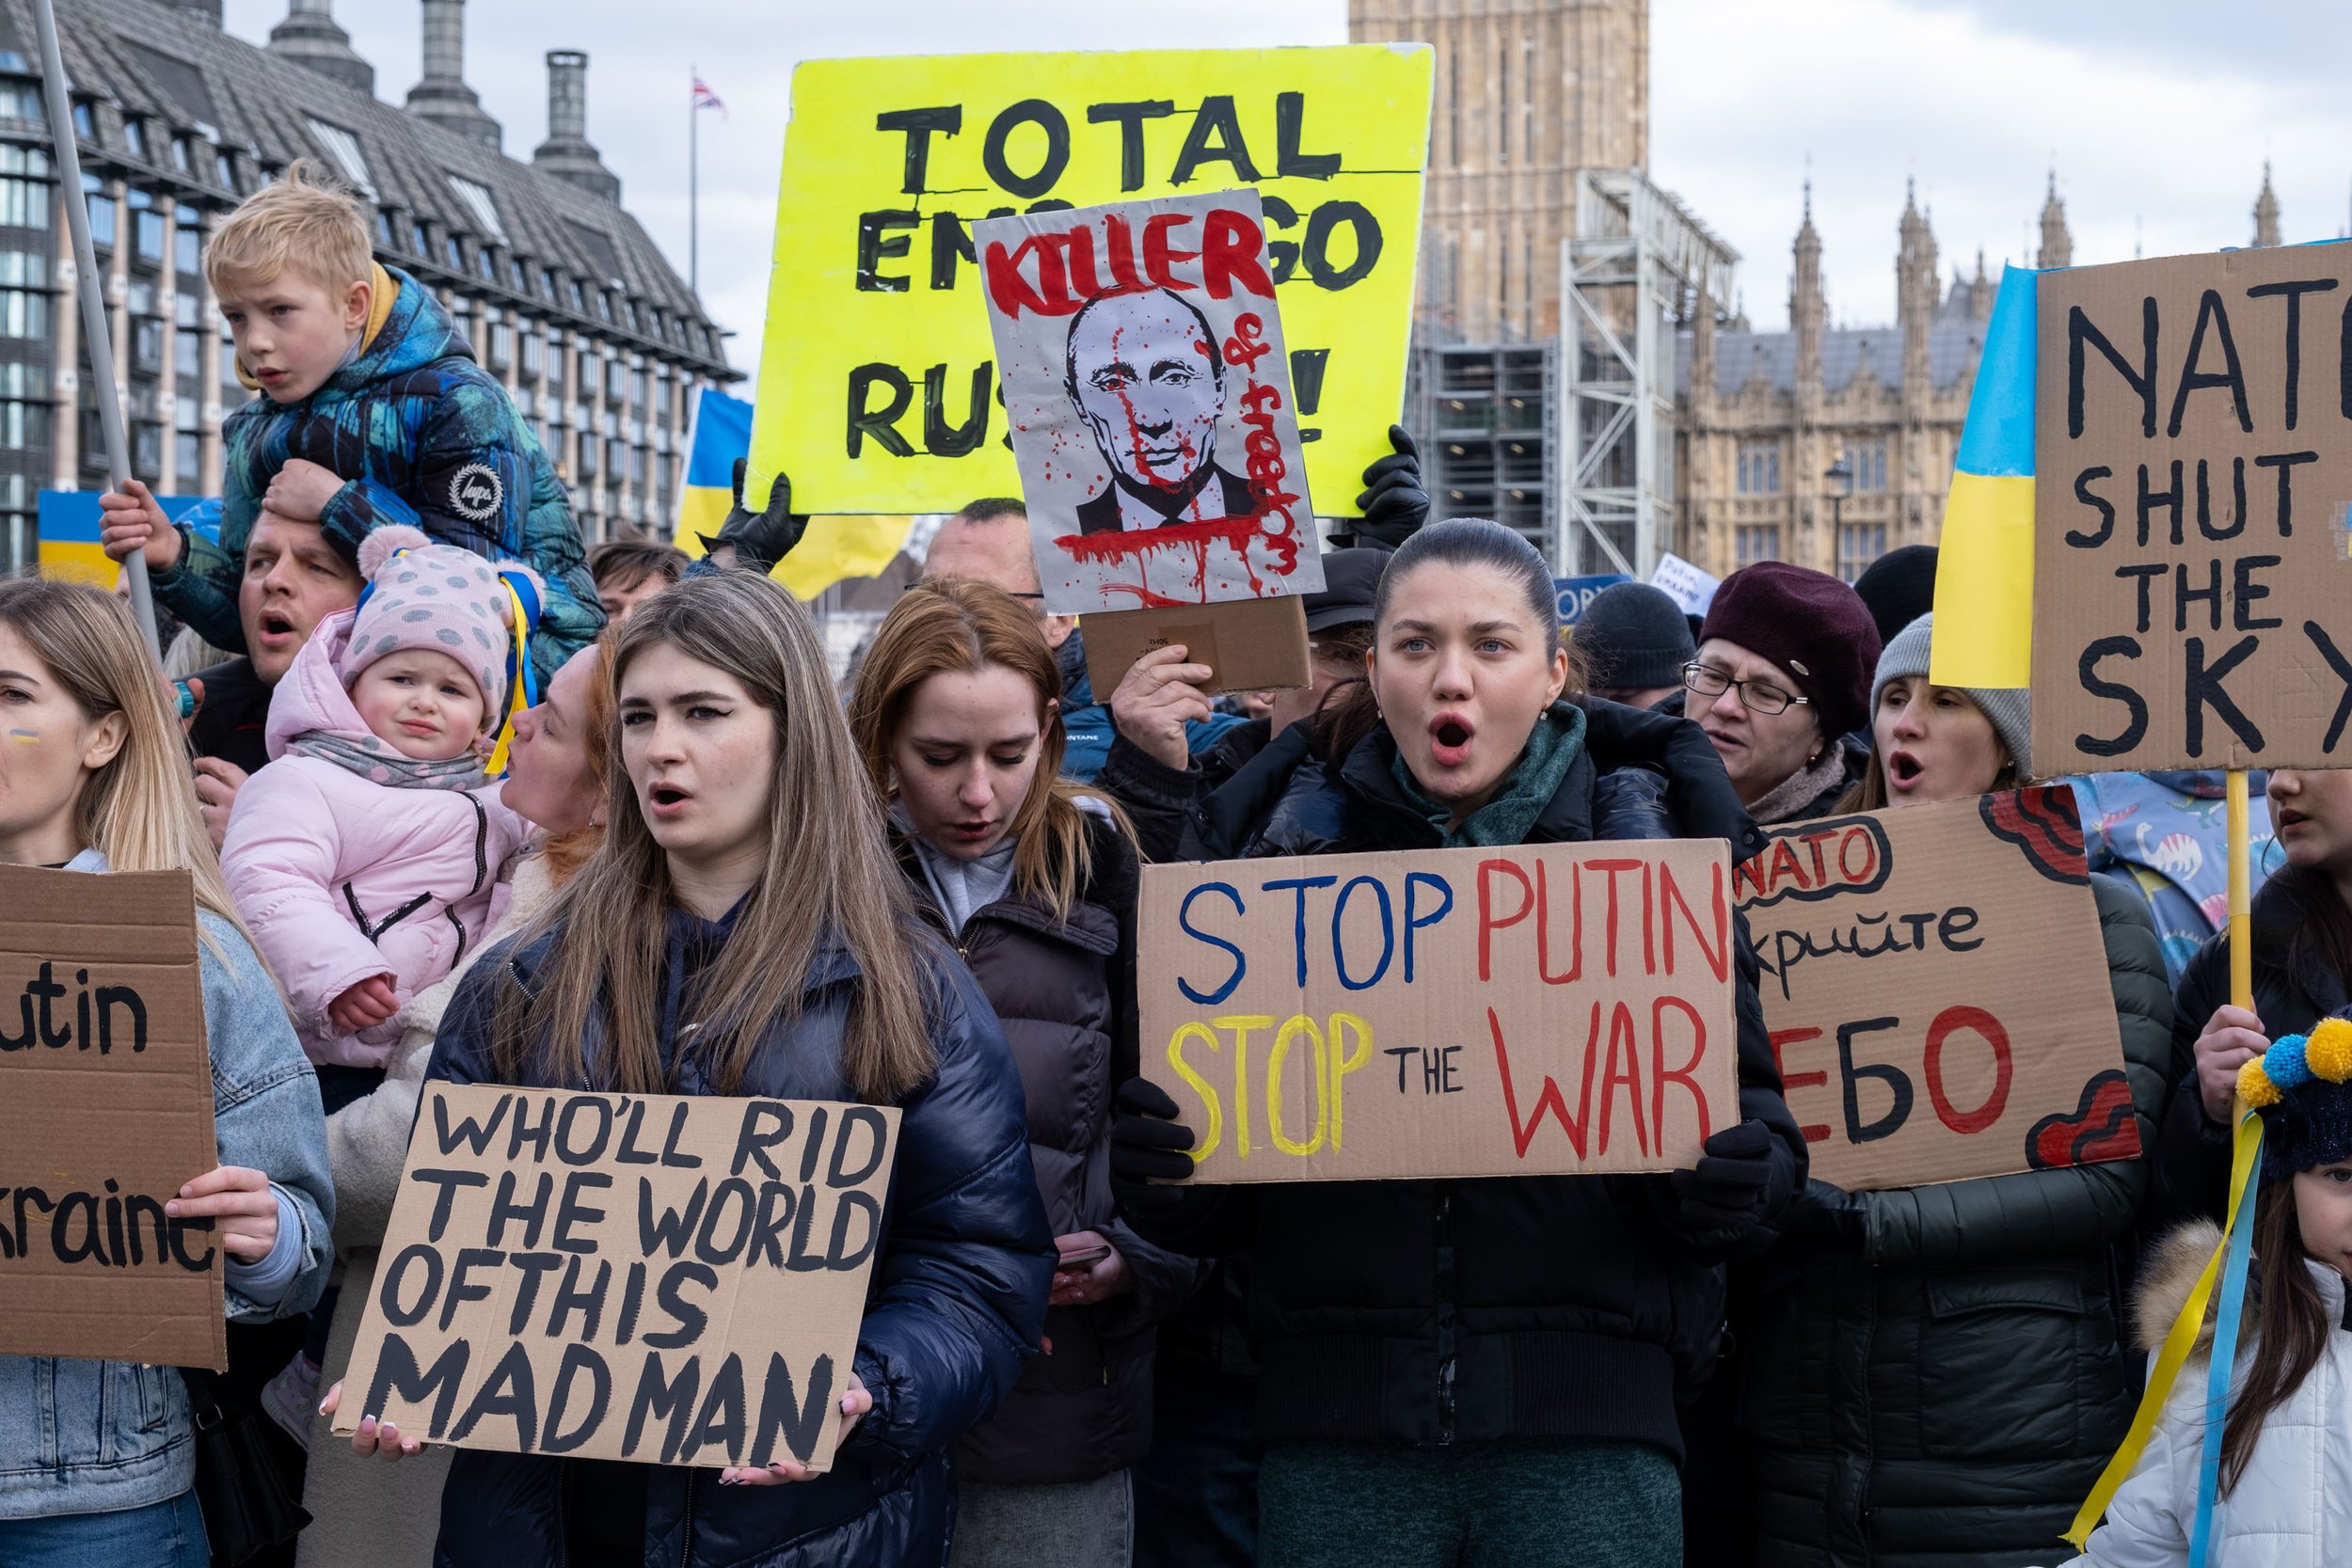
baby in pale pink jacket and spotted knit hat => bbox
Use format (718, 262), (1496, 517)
(221, 527), (536, 1101)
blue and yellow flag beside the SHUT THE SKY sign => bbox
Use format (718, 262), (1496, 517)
(1929, 265), (2040, 687)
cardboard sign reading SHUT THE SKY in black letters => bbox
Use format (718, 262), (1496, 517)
(2032, 245), (2352, 776)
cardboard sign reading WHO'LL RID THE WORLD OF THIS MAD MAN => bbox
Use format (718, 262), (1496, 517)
(334, 1084), (898, 1472)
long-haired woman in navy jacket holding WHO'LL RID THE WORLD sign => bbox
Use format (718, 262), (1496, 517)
(329, 571), (1054, 1568)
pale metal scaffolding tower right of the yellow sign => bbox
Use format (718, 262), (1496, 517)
(1550, 169), (1740, 580)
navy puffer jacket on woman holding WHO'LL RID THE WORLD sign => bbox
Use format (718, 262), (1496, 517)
(426, 893), (1054, 1568)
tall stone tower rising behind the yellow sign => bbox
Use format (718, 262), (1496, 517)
(1348, 0), (1649, 343)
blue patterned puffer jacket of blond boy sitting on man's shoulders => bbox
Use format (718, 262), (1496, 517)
(155, 268), (605, 679)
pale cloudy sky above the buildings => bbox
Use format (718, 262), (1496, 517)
(212, 0), (2352, 369)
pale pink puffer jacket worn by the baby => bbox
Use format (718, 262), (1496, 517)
(221, 609), (532, 1068)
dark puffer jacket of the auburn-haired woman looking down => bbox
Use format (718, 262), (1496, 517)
(901, 816), (1202, 1486)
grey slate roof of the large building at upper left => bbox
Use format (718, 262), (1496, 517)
(0, 0), (737, 381)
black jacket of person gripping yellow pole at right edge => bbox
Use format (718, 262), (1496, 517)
(2148, 872), (2352, 1234)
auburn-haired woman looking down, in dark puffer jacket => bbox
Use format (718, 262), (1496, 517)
(850, 580), (1198, 1568)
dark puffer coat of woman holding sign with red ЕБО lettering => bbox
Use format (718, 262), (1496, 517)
(1743, 877), (2169, 1568)
